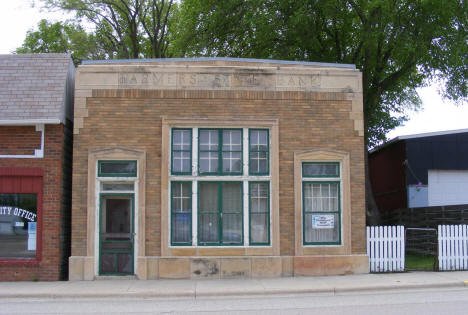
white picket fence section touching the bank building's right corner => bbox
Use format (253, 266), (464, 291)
(367, 226), (405, 272)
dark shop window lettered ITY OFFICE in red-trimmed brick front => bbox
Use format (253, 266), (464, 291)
(0, 194), (37, 258)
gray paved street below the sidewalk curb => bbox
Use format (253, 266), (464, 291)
(0, 288), (468, 315)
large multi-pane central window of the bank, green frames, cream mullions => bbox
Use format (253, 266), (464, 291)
(169, 128), (271, 246)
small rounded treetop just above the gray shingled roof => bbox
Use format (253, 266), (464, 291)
(15, 20), (105, 65)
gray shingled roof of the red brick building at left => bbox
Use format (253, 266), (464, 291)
(0, 54), (74, 122)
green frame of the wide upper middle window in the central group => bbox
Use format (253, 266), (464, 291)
(198, 128), (244, 176)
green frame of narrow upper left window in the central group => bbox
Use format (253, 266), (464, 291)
(171, 128), (192, 175)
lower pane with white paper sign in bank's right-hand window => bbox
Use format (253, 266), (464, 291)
(304, 213), (340, 243)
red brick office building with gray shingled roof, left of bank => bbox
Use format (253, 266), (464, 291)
(0, 54), (75, 280)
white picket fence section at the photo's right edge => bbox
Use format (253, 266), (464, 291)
(438, 224), (468, 270)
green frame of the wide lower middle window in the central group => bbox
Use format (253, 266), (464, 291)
(197, 181), (244, 246)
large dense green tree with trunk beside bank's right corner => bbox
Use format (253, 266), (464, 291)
(173, 0), (468, 222)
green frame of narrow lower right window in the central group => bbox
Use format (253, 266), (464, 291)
(249, 182), (270, 246)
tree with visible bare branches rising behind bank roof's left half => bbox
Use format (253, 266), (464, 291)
(41, 0), (177, 59)
